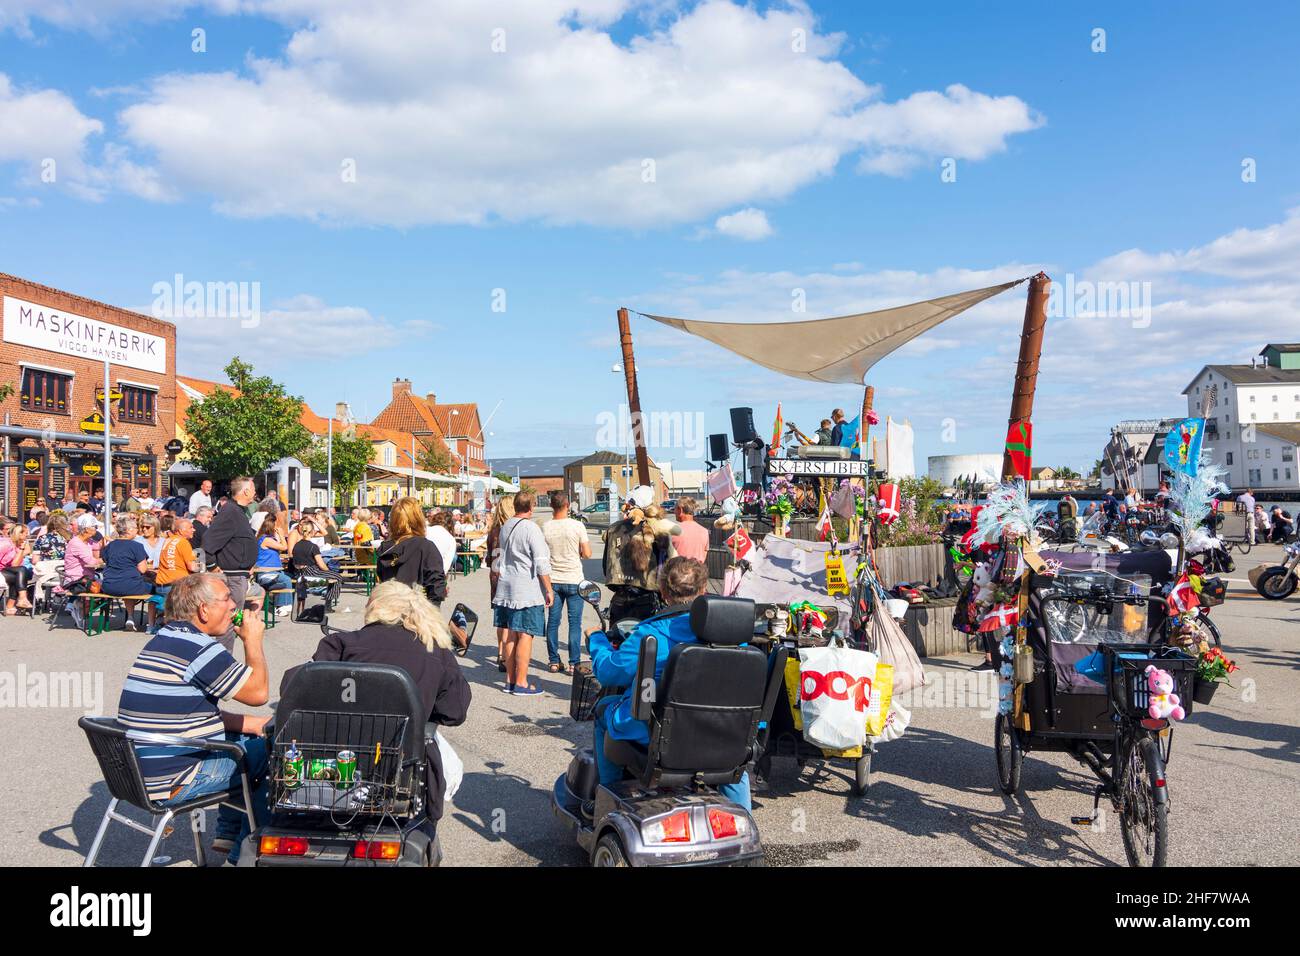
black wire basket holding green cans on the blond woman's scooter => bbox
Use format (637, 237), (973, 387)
(268, 710), (415, 817)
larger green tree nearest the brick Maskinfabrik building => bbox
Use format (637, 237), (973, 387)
(185, 355), (312, 480)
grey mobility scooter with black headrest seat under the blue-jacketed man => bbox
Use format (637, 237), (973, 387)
(551, 581), (784, 866)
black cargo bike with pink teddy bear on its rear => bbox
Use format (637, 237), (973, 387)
(993, 550), (1196, 866)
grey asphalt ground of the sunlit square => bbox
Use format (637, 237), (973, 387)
(0, 533), (1300, 866)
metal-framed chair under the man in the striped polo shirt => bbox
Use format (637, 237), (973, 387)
(77, 717), (257, 866)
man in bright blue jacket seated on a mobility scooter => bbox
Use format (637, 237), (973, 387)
(588, 557), (751, 810)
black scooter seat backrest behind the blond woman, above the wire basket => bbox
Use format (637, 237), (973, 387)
(276, 661), (426, 760)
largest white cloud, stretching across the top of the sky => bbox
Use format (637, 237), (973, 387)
(0, 0), (1040, 228)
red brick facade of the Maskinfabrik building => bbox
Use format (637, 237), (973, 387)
(0, 273), (177, 514)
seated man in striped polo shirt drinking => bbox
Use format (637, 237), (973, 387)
(117, 574), (269, 864)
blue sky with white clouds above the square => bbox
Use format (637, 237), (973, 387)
(0, 0), (1300, 471)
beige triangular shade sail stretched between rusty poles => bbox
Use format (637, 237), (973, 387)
(638, 278), (1024, 385)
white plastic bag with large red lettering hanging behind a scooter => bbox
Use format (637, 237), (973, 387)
(800, 645), (879, 750)
